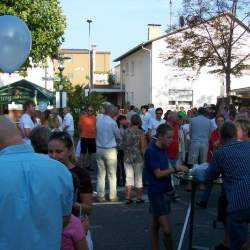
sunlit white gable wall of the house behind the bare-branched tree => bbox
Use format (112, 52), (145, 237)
(152, 29), (250, 110)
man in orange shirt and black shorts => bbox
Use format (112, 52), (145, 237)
(78, 106), (96, 170)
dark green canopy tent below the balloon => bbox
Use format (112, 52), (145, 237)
(0, 79), (55, 104)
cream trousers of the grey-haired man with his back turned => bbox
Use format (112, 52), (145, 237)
(96, 148), (117, 199)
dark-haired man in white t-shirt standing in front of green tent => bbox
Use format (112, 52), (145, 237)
(19, 100), (36, 145)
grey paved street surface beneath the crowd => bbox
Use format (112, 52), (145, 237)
(87, 169), (223, 250)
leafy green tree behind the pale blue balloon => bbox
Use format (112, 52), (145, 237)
(0, 0), (66, 71)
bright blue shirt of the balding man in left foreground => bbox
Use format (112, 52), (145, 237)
(0, 144), (73, 250)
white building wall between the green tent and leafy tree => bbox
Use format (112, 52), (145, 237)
(0, 59), (54, 91)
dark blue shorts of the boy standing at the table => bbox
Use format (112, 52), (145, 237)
(148, 193), (173, 217)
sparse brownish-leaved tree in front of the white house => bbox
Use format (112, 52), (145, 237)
(163, 0), (250, 102)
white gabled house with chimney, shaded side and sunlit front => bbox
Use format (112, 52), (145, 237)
(115, 14), (250, 110)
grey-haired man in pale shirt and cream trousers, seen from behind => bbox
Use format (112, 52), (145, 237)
(96, 104), (121, 202)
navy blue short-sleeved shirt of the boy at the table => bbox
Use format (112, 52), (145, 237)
(145, 142), (173, 194)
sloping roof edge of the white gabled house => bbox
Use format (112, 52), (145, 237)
(114, 13), (250, 62)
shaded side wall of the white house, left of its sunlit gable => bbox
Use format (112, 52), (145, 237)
(120, 47), (151, 107)
